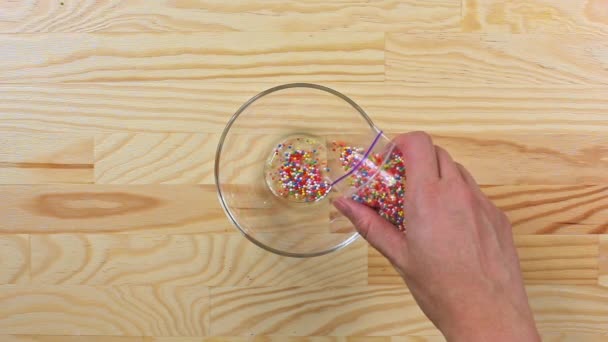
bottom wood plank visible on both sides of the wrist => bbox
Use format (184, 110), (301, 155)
(210, 285), (608, 336)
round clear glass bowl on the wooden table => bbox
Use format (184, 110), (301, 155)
(215, 83), (388, 257)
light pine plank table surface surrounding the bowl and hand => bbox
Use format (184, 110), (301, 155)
(0, 0), (608, 342)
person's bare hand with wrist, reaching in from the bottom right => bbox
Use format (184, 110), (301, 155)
(334, 132), (540, 342)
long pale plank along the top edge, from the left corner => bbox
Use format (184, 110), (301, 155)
(0, 0), (460, 33)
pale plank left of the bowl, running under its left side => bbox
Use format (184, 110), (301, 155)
(95, 133), (285, 187)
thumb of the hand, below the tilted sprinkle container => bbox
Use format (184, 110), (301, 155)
(334, 198), (406, 265)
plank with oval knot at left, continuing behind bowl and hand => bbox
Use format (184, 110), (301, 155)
(0, 185), (608, 235)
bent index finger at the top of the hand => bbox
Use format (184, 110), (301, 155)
(393, 132), (439, 186)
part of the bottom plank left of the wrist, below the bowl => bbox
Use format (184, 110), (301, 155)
(210, 286), (439, 336)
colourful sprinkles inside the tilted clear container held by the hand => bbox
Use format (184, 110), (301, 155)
(332, 142), (405, 231)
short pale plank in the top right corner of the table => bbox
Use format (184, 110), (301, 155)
(462, 0), (608, 33)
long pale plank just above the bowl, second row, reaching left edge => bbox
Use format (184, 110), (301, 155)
(0, 32), (384, 83)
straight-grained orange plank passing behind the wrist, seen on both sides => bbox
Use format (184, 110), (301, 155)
(368, 235), (599, 285)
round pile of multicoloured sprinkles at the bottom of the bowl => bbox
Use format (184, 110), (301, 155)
(267, 137), (331, 202)
